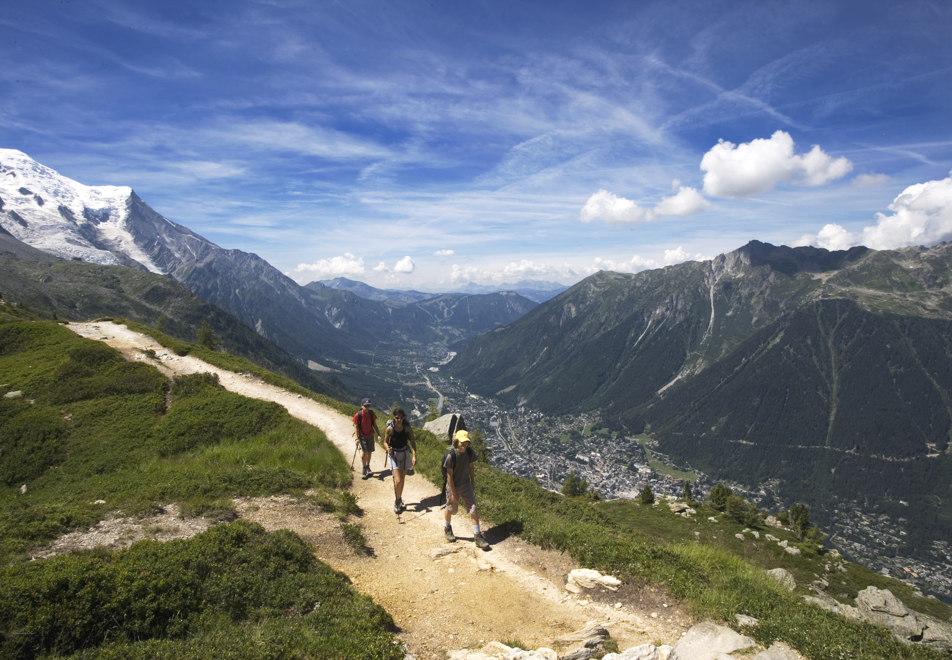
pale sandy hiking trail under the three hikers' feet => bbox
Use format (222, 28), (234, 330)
(67, 322), (695, 660)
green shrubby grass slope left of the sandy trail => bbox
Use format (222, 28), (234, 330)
(0, 305), (402, 658)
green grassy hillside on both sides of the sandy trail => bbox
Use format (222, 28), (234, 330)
(0, 306), (948, 659)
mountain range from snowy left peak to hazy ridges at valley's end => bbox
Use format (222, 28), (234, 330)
(0, 149), (535, 376)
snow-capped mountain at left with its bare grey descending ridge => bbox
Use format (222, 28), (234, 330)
(0, 149), (352, 362)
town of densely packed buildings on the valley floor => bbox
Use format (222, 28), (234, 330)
(366, 346), (952, 602)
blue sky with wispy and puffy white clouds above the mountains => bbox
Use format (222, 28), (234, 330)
(0, 0), (952, 290)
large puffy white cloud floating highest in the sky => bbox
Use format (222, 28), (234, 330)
(701, 131), (853, 197)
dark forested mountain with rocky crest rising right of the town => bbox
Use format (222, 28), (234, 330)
(446, 241), (952, 550)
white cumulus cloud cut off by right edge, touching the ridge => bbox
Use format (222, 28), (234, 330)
(794, 173), (952, 250)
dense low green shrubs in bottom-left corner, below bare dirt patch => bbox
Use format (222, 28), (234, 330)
(0, 521), (402, 659)
